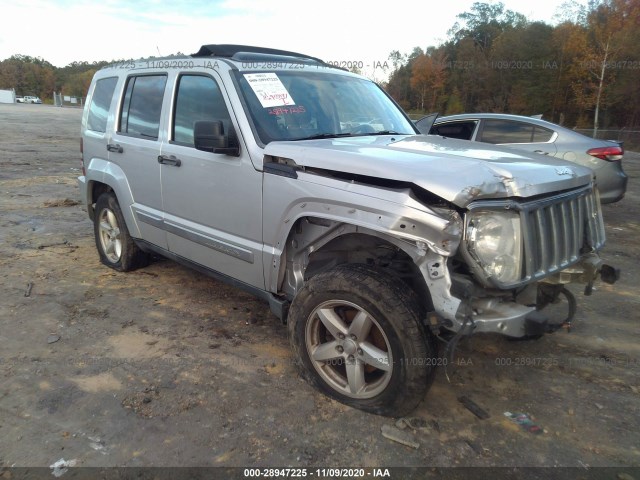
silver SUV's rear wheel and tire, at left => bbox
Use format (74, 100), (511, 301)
(93, 192), (149, 272)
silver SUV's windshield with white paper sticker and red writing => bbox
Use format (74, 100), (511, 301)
(236, 71), (416, 144)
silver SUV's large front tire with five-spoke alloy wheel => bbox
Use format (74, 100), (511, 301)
(288, 264), (437, 417)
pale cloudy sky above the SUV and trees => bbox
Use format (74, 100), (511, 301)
(0, 0), (586, 77)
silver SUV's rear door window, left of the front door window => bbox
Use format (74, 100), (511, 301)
(118, 75), (167, 139)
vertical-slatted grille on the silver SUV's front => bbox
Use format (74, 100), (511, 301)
(520, 188), (605, 283)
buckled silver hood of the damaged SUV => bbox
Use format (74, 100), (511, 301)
(264, 135), (593, 207)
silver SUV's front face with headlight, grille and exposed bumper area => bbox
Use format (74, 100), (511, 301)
(425, 185), (619, 337)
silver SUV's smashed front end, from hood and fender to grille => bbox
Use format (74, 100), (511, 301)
(264, 136), (617, 337)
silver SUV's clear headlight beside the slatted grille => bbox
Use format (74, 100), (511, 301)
(466, 210), (522, 285)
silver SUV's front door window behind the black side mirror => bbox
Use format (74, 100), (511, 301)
(172, 75), (231, 146)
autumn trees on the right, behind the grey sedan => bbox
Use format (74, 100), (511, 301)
(386, 0), (640, 128)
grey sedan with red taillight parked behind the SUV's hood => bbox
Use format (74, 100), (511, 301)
(416, 113), (627, 203)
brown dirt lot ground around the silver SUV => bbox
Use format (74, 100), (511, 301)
(0, 105), (640, 472)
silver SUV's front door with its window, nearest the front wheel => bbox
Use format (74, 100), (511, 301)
(161, 72), (264, 288)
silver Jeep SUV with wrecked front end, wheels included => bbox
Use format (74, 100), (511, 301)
(79, 45), (617, 415)
